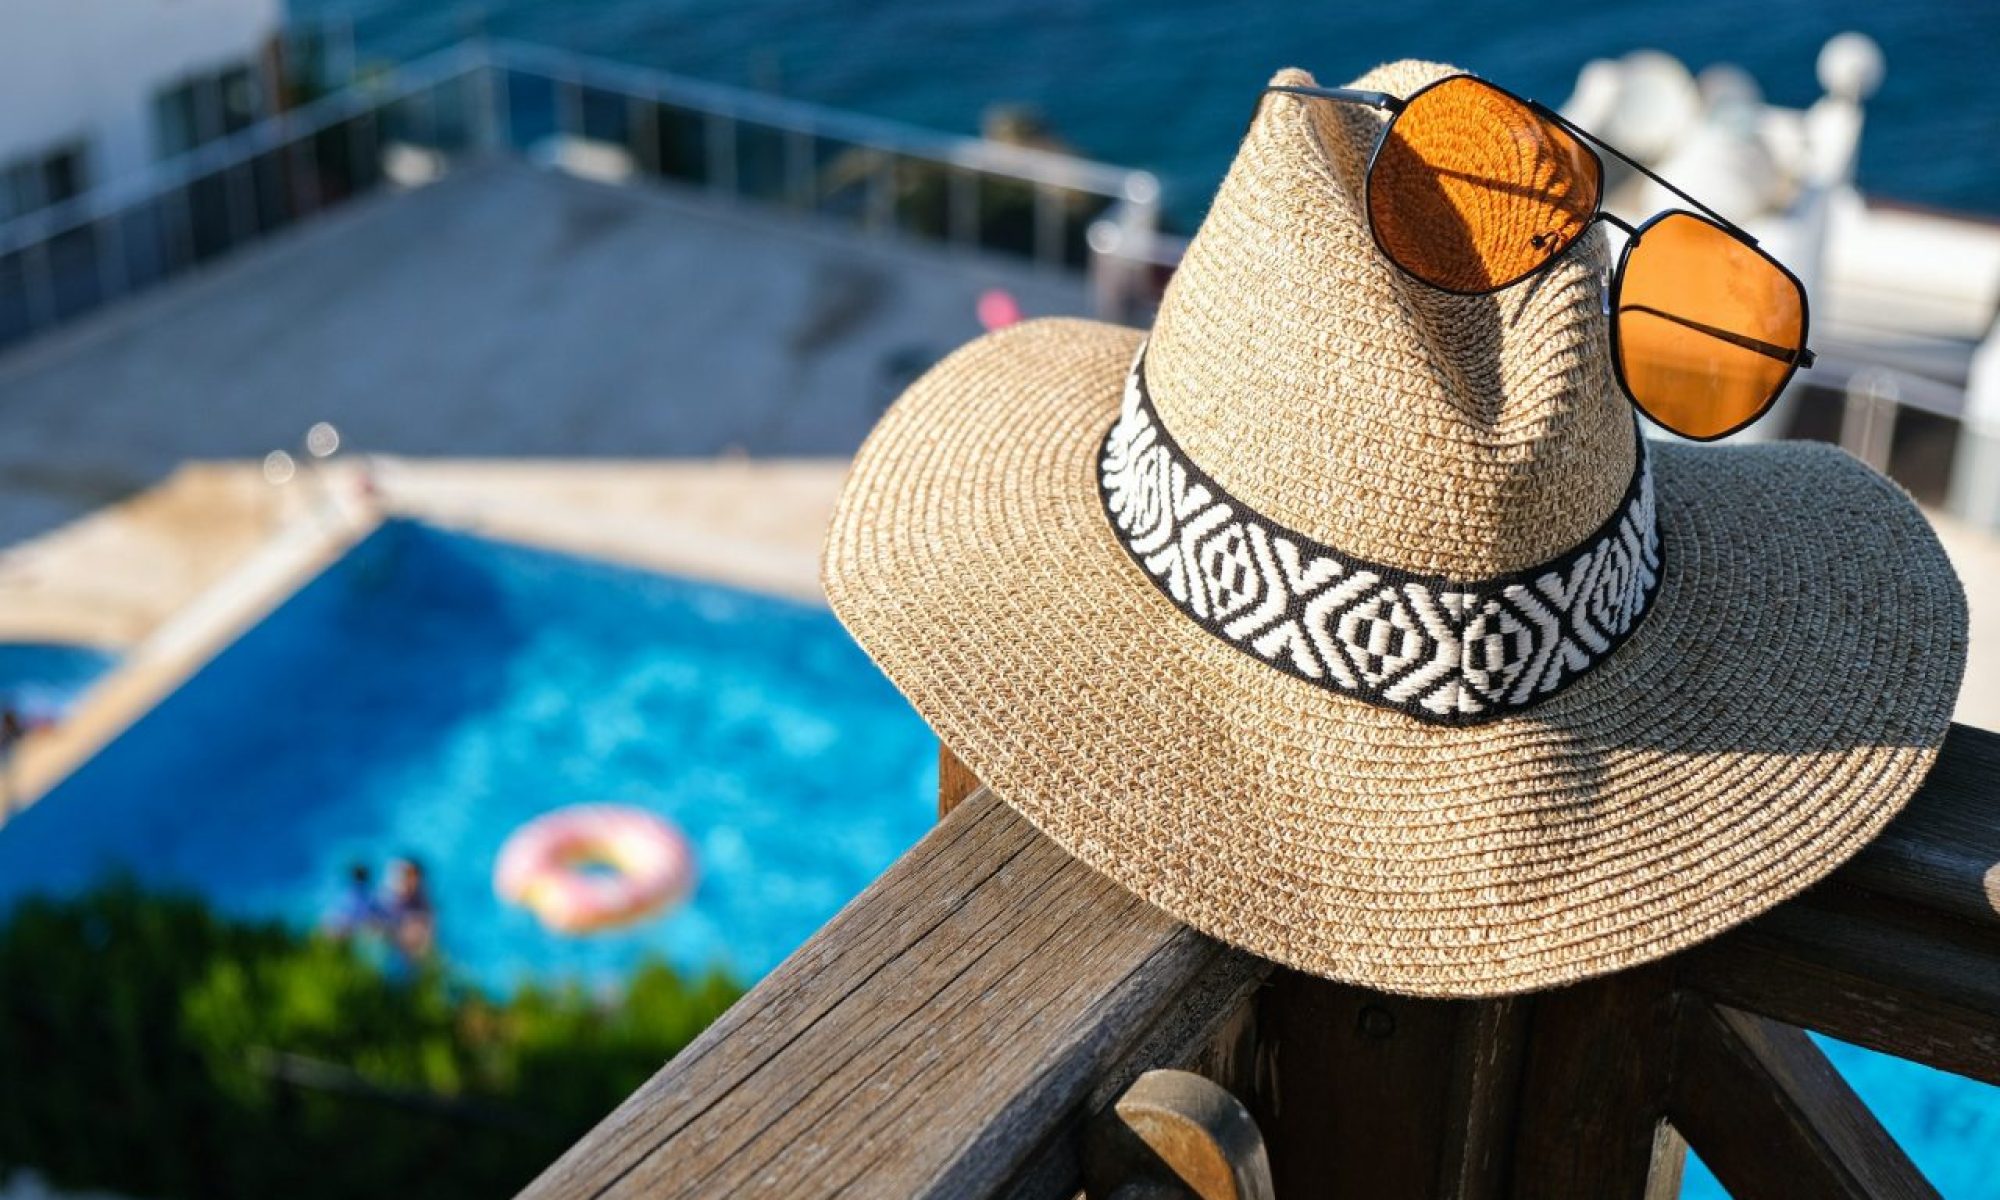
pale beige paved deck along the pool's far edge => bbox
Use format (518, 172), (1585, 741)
(0, 458), (846, 650)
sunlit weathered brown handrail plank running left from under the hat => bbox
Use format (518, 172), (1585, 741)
(524, 792), (1266, 1200)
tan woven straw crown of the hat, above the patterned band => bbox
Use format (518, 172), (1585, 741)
(1146, 62), (1634, 578)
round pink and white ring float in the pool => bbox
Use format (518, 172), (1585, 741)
(494, 804), (694, 934)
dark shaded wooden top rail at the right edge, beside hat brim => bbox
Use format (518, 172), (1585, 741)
(1834, 726), (2000, 924)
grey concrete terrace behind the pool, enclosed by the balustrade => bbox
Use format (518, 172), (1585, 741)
(0, 160), (1088, 546)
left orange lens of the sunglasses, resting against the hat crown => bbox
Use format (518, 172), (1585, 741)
(1368, 76), (1598, 292)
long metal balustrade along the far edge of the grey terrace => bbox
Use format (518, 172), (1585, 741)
(0, 42), (1160, 348)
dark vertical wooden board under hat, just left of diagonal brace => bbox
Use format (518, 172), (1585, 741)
(1514, 968), (1684, 1200)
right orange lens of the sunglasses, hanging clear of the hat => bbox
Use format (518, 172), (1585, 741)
(1612, 212), (1806, 438)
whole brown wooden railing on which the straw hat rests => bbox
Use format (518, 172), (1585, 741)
(526, 728), (2000, 1200)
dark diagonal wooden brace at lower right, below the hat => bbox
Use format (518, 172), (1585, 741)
(1668, 1000), (1938, 1200)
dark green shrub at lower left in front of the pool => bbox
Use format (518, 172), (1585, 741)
(0, 884), (740, 1200)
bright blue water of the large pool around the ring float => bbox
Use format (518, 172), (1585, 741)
(0, 524), (936, 988)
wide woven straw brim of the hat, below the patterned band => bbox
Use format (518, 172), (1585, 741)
(826, 320), (1966, 996)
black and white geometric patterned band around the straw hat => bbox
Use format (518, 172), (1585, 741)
(1098, 348), (1664, 724)
